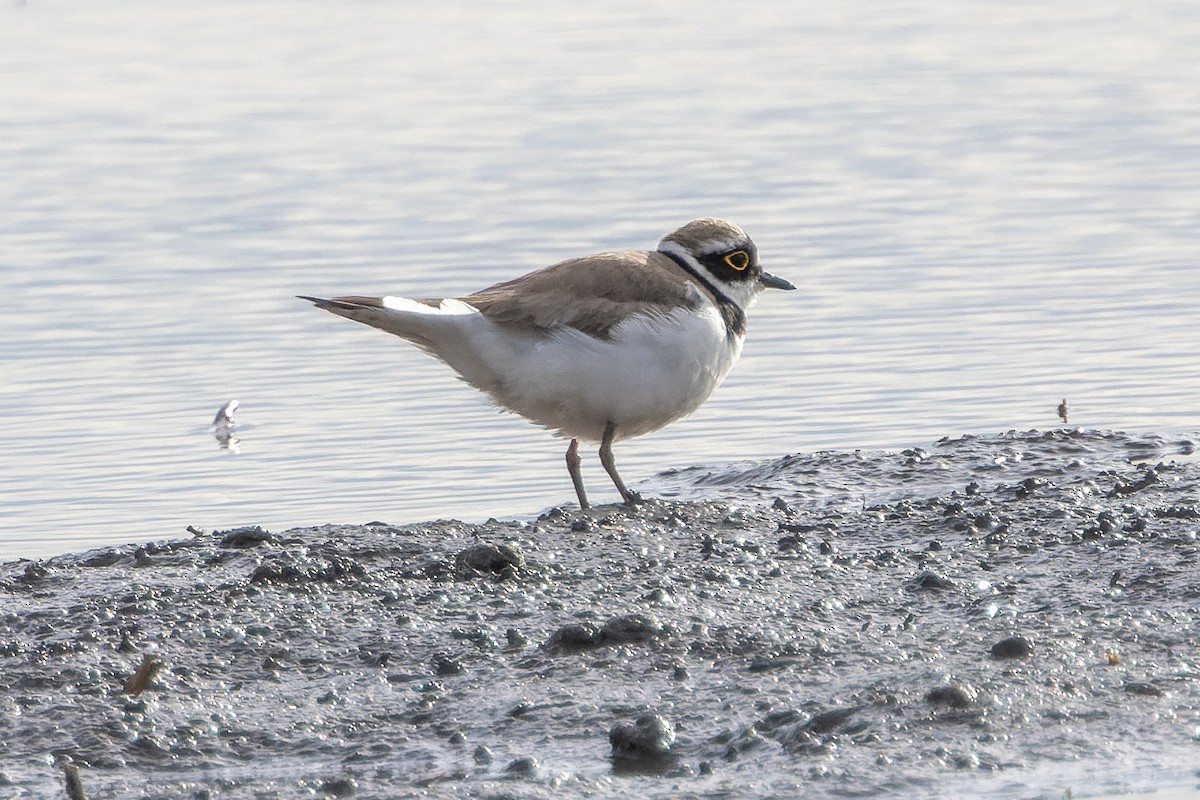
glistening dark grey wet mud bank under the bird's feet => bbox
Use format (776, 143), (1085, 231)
(0, 431), (1200, 799)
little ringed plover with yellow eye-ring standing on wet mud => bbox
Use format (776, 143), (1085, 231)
(300, 218), (796, 509)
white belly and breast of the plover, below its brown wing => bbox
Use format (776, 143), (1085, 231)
(470, 306), (742, 441)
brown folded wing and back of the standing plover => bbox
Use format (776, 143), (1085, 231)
(460, 251), (696, 338)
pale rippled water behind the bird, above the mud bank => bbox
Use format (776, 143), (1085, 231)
(0, 0), (1200, 558)
